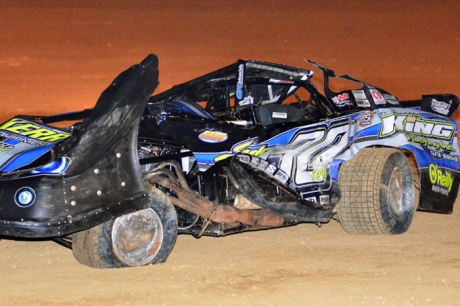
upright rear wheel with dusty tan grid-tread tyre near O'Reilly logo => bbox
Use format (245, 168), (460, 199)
(337, 148), (415, 235)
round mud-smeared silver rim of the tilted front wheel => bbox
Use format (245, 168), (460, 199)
(112, 208), (163, 266)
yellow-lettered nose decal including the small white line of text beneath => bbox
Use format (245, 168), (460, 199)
(0, 118), (70, 145)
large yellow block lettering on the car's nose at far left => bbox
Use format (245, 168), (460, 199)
(0, 118), (70, 142)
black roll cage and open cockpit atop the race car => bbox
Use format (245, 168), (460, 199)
(148, 60), (339, 125)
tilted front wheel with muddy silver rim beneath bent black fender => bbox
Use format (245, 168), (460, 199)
(72, 186), (177, 268)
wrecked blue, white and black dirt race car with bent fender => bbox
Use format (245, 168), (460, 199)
(0, 55), (460, 268)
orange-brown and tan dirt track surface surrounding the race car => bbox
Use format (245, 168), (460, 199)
(0, 0), (460, 306)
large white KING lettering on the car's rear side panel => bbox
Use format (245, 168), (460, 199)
(380, 113), (455, 140)
